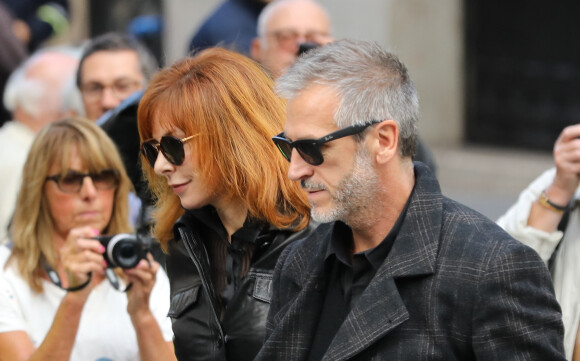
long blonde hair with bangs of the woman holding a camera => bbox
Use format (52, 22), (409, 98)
(9, 118), (132, 292)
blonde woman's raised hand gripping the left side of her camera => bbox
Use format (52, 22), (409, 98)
(60, 227), (107, 288)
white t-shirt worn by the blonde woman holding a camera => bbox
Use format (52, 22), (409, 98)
(0, 246), (173, 361)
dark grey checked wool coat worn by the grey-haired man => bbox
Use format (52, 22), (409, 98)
(256, 163), (564, 361)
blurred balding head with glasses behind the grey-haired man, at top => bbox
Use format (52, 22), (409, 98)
(251, 0), (332, 78)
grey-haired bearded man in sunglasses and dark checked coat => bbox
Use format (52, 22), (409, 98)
(257, 40), (565, 361)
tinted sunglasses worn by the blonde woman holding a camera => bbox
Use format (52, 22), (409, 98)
(45, 169), (120, 193)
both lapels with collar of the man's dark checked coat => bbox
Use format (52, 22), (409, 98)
(285, 163), (443, 360)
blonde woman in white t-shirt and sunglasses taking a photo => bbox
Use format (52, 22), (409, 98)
(0, 118), (176, 361)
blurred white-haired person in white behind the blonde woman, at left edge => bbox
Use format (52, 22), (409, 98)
(0, 46), (80, 243)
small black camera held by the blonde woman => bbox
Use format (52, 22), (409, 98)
(95, 233), (148, 268)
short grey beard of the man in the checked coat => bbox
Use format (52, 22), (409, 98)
(311, 146), (381, 227)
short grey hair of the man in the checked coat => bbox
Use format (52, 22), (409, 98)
(277, 39), (419, 156)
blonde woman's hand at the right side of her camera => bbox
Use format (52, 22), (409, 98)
(123, 253), (159, 318)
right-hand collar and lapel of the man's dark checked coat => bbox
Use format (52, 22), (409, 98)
(323, 167), (443, 361)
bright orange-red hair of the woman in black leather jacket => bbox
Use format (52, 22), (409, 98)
(138, 48), (310, 249)
